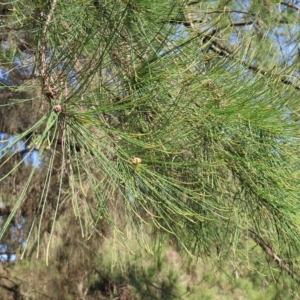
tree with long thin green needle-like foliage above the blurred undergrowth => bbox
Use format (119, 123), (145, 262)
(0, 0), (300, 299)
